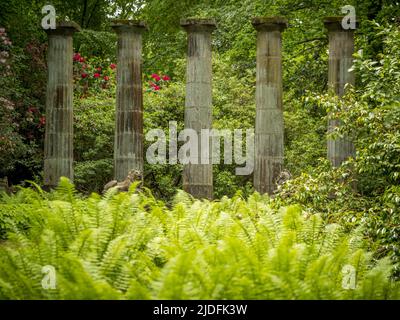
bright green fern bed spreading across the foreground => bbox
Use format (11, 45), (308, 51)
(0, 179), (400, 299)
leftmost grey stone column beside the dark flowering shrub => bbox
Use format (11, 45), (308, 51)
(44, 22), (80, 187)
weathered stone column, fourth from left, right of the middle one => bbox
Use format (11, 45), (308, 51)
(252, 17), (287, 194)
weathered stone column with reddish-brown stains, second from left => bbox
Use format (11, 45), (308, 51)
(112, 20), (146, 181)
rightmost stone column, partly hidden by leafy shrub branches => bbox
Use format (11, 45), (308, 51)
(324, 17), (355, 167)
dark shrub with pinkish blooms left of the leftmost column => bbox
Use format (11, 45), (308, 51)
(0, 28), (46, 180)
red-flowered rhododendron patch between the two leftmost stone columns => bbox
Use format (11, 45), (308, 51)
(73, 53), (117, 96)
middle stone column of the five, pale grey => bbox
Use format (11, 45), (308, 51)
(181, 19), (216, 199)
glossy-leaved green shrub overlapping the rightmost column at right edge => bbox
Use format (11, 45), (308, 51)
(277, 25), (400, 276)
